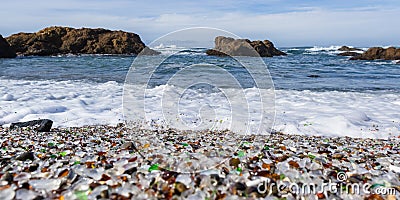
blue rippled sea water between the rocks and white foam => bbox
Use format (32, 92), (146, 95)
(0, 47), (400, 92)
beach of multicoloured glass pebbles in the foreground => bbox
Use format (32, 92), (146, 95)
(0, 126), (400, 199)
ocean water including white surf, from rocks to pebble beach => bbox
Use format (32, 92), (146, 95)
(0, 46), (400, 138)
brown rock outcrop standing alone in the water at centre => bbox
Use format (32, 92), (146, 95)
(206, 36), (286, 57)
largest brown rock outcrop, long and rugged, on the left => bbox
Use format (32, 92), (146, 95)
(6, 27), (157, 56)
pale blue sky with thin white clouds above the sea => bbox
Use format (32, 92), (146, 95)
(0, 0), (400, 47)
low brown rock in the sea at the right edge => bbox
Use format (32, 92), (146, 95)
(350, 47), (400, 60)
